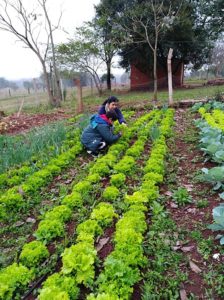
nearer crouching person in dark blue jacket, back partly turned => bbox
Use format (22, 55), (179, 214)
(81, 111), (121, 156)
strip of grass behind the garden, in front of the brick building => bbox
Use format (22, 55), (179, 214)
(0, 86), (224, 113)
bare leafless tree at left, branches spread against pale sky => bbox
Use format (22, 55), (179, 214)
(0, 0), (61, 106)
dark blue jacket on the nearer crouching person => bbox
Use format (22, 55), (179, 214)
(81, 115), (120, 151)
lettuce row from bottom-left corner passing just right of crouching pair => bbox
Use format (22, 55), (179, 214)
(1, 108), (162, 299)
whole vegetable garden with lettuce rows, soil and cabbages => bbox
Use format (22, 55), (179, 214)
(0, 101), (224, 300)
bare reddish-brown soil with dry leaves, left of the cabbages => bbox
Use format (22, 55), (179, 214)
(163, 110), (221, 299)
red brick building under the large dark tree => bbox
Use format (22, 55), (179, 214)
(130, 60), (184, 91)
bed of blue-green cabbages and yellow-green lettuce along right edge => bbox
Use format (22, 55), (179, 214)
(195, 102), (224, 245)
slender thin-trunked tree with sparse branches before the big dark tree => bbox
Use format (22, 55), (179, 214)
(108, 0), (182, 101)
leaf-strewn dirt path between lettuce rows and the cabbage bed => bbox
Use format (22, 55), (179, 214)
(163, 109), (224, 299)
